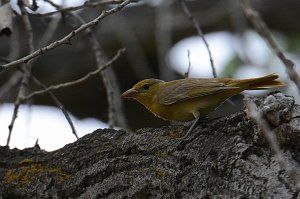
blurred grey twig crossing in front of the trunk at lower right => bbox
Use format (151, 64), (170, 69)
(246, 96), (300, 191)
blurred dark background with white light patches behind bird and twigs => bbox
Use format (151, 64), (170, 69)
(0, 0), (300, 150)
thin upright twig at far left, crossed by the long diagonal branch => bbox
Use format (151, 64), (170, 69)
(6, 0), (34, 146)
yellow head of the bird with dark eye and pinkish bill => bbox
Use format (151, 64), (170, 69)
(121, 79), (164, 105)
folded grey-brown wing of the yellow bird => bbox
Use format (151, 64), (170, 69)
(159, 78), (237, 105)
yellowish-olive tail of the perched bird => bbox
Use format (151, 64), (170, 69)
(231, 73), (285, 90)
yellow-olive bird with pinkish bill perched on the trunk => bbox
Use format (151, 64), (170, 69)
(121, 73), (285, 138)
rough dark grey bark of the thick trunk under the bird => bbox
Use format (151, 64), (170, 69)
(0, 93), (300, 198)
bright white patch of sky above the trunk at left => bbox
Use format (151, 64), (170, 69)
(0, 104), (108, 151)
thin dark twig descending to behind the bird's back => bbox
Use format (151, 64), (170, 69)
(178, 0), (217, 78)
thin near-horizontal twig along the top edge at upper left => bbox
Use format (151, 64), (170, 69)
(30, 0), (138, 17)
